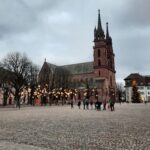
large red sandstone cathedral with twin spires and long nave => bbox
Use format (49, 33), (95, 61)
(39, 10), (116, 95)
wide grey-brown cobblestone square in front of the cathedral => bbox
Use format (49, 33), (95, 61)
(0, 104), (150, 150)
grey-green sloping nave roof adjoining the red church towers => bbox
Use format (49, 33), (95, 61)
(61, 62), (94, 74)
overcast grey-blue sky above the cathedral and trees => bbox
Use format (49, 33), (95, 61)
(0, 0), (150, 82)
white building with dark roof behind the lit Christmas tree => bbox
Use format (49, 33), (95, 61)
(124, 73), (150, 102)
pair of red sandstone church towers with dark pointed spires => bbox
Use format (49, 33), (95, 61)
(93, 10), (116, 96)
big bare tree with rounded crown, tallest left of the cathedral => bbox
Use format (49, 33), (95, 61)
(3, 52), (32, 104)
